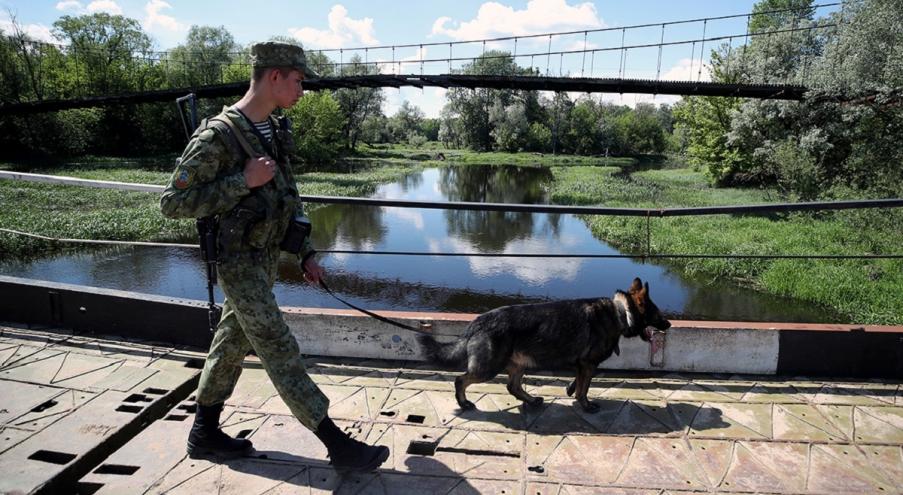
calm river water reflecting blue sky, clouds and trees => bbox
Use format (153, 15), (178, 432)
(0, 166), (840, 322)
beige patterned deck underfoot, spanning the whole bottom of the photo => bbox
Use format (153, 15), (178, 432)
(0, 329), (903, 495)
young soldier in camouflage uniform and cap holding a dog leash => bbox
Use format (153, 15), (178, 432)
(160, 42), (389, 471)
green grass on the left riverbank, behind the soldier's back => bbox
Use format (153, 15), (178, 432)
(0, 160), (419, 260)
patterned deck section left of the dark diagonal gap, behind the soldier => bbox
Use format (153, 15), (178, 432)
(0, 327), (200, 493)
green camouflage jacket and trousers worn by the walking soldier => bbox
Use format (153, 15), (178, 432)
(160, 43), (329, 430)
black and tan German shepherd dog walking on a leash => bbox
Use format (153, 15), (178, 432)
(417, 278), (671, 412)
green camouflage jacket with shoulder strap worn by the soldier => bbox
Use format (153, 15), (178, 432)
(160, 107), (311, 260)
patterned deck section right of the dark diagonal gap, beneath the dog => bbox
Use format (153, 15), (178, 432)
(99, 361), (903, 494)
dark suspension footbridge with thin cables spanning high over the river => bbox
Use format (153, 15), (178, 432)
(0, 2), (861, 115)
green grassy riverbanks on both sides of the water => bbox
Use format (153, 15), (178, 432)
(0, 156), (903, 324)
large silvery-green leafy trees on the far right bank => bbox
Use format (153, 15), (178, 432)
(674, 0), (903, 199)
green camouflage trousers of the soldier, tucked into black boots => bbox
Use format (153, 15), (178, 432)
(197, 248), (329, 430)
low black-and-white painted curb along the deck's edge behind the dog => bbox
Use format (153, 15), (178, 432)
(0, 276), (903, 378)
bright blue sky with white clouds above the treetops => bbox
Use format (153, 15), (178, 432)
(0, 0), (840, 117)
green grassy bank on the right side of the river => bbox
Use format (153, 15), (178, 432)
(551, 167), (903, 324)
